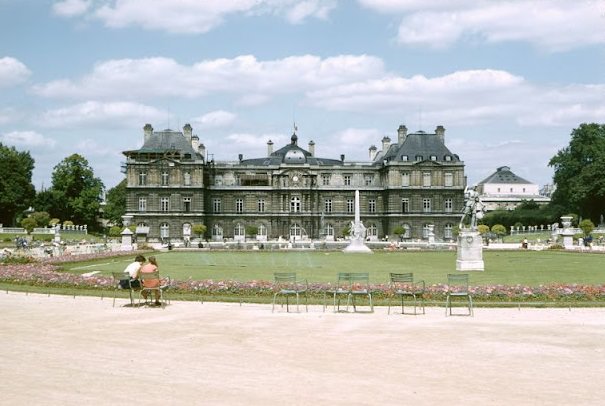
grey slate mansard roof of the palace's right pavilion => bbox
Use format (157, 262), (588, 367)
(377, 131), (460, 162)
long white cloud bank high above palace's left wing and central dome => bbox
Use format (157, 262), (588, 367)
(34, 55), (384, 102)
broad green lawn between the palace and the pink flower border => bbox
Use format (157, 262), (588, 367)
(60, 251), (605, 286)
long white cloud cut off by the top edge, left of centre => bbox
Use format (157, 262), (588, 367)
(53, 0), (337, 34)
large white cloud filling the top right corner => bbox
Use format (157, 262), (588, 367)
(358, 0), (605, 51)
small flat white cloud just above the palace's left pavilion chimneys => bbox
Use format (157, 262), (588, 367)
(40, 101), (167, 127)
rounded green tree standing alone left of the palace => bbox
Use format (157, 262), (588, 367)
(51, 154), (103, 229)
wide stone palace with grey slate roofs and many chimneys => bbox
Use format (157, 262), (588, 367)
(124, 124), (466, 241)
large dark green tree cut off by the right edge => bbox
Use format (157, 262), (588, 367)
(549, 123), (605, 221)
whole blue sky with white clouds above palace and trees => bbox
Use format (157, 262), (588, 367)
(0, 0), (605, 190)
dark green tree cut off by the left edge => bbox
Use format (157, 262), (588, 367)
(0, 143), (36, 226)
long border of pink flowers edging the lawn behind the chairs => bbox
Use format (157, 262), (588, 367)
(0, 251), (605, 303)
